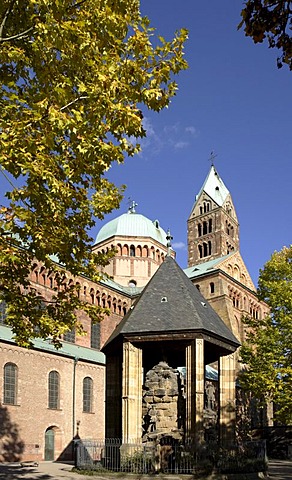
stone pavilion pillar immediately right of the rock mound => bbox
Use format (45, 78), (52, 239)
(186, 338), (205, 446)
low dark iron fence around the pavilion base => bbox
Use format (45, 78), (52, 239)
(75, 438), (266, 475)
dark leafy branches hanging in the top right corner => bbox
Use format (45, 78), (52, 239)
(239, 0), (292, 70)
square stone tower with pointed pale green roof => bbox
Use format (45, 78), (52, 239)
(188, 164), (239, 267)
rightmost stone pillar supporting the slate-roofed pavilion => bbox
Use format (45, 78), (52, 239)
(219, 354), (236, 448)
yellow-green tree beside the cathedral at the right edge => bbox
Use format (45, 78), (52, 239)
(241, 246), (292, 424)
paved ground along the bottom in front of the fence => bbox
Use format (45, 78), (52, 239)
(0, 460), (292, 480)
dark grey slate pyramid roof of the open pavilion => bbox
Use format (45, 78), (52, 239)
(106, 256), (239, 346)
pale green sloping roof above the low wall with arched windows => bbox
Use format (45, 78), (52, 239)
(0, 325), (105, 365)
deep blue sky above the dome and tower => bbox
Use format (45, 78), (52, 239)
(0, 0), (292, 283)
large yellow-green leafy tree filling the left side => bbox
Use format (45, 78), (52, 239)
(0, 0), (187, 346)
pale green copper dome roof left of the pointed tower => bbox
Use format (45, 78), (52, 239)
(95, 209), (167, 246)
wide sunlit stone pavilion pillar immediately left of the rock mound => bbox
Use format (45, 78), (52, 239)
(122, 342), (143, 443)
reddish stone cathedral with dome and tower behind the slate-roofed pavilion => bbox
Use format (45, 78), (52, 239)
(0, 165), (268, 461)
